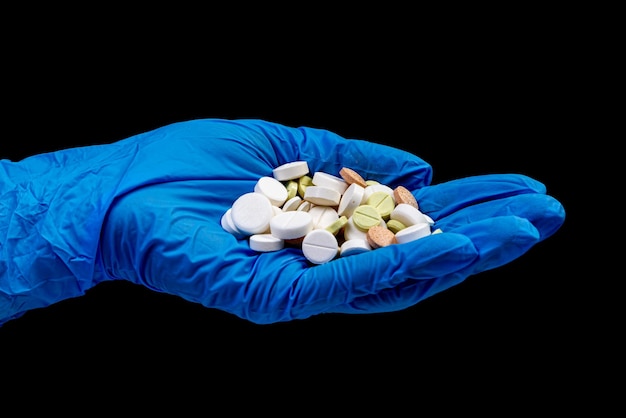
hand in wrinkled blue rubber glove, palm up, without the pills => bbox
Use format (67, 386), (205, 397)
(0, 119), (565, 324)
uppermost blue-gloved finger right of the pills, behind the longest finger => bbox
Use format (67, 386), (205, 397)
(413, 174), (546, 219)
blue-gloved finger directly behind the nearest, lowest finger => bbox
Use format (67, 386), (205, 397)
(328, 216), (539, 313)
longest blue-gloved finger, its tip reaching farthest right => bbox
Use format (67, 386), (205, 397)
(436, 194), (565, 241)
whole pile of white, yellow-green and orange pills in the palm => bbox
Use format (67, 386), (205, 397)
(221, 161), (441, 264)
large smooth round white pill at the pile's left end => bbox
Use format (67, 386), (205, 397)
(231, 192), (274, 235)
